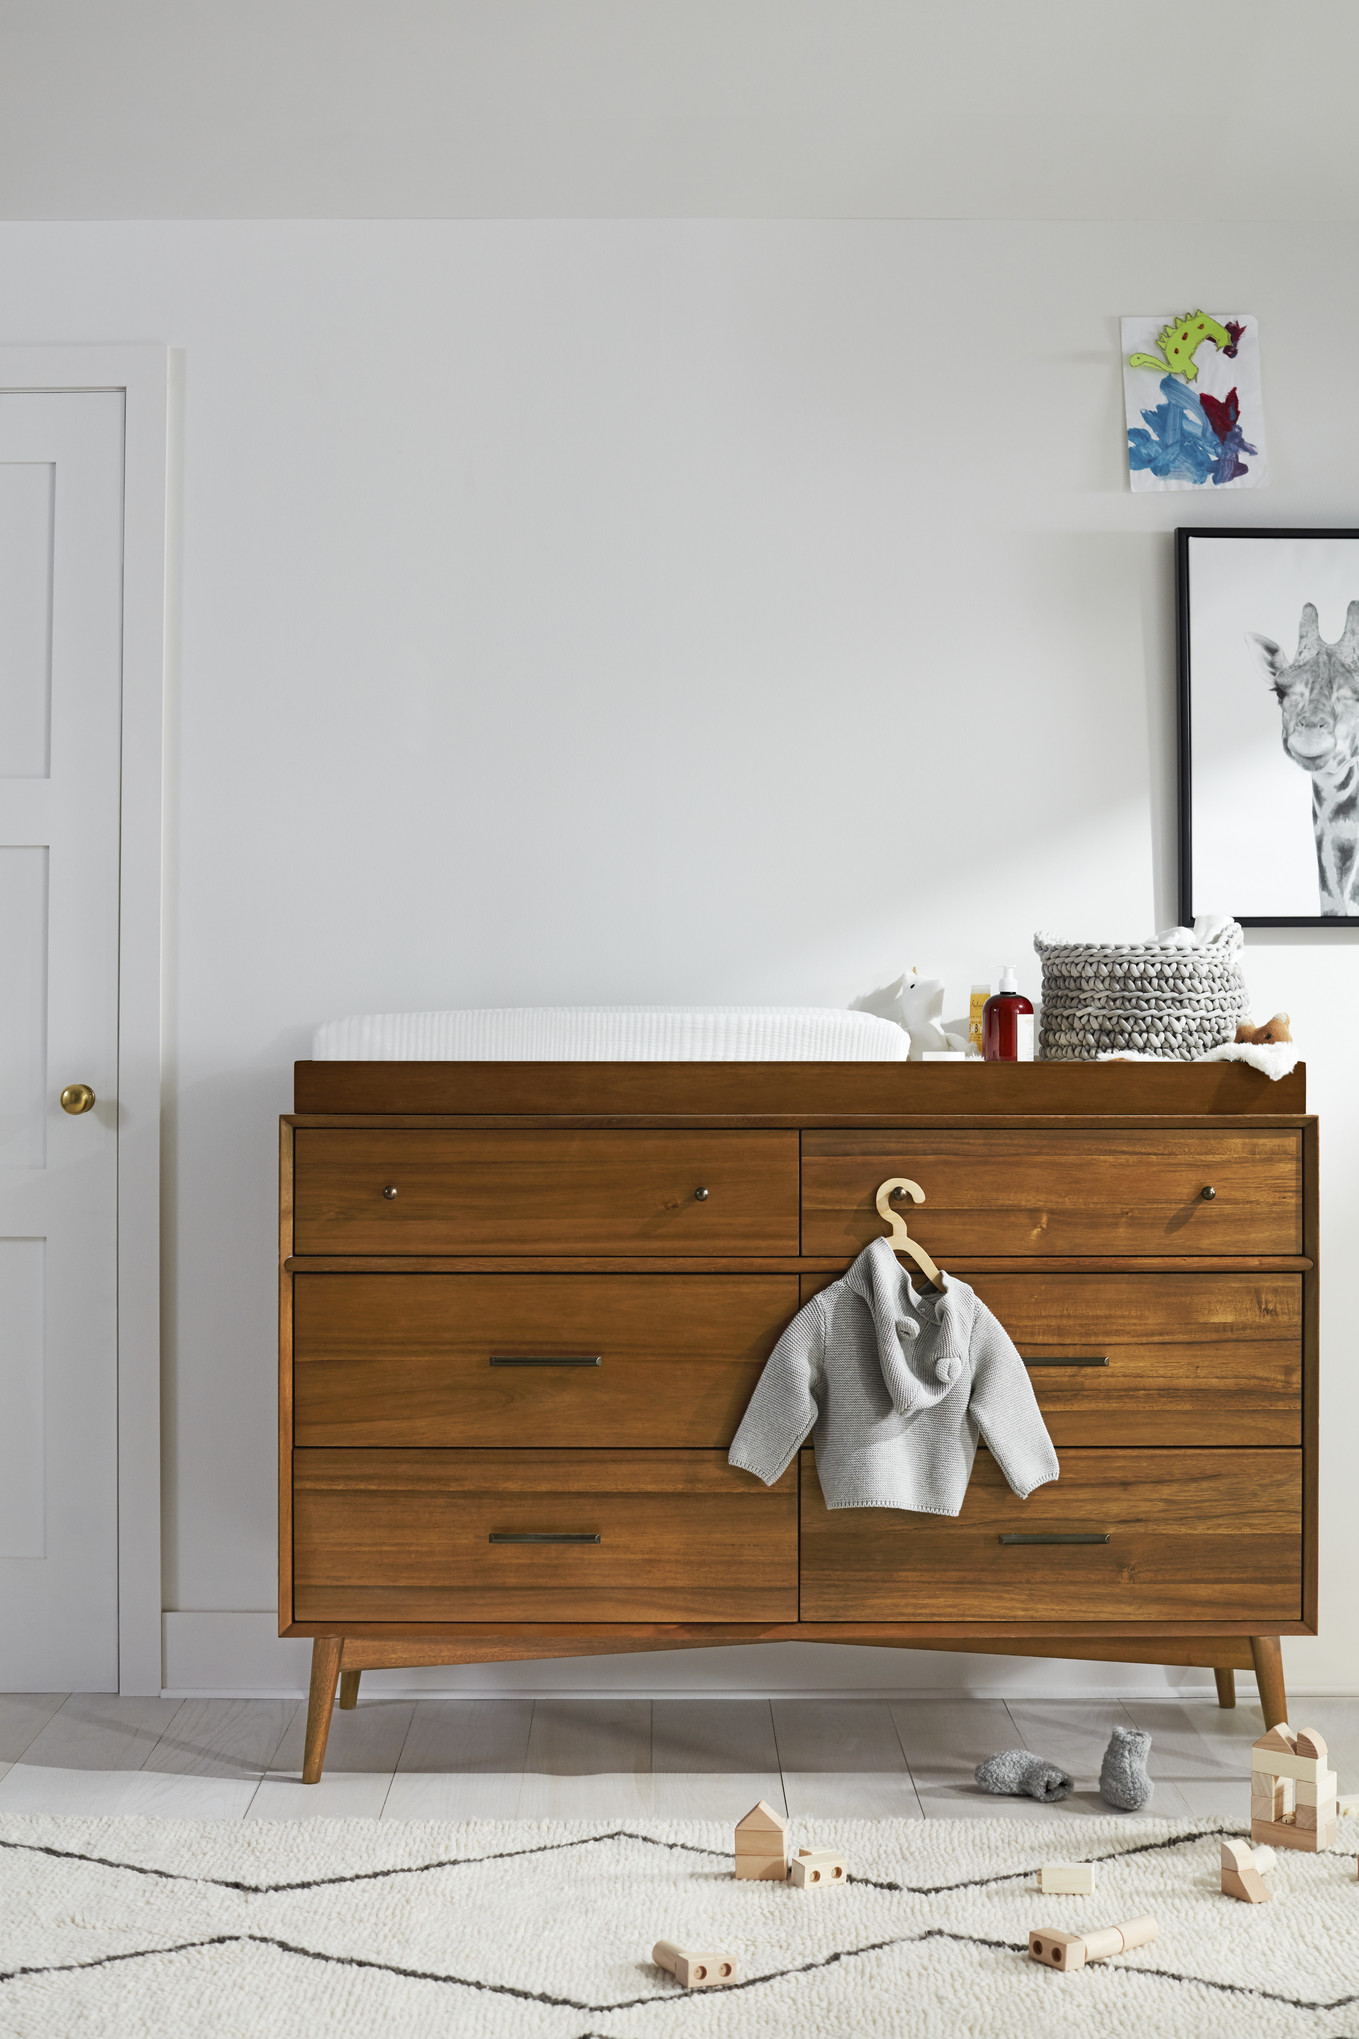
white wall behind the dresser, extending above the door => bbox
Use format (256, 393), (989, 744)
(0, 216), (1359, 1690)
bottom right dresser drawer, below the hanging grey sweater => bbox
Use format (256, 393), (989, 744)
(801, 1450), (1302, 1631)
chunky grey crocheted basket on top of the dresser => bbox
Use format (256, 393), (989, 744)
(1033, 922), (1249, 1062)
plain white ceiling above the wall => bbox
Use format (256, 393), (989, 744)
(0, 0), (1359, 220)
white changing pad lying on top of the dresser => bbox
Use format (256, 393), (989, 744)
(312, 1005), (911, 1062)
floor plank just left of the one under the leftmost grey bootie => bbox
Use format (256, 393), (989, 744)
(772, 1698), (921, 1819)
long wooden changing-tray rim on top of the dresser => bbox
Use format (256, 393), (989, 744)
(293, 1062), (1306, 1123)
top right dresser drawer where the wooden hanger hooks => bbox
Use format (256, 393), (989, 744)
(803, 1128), (1302, 1260)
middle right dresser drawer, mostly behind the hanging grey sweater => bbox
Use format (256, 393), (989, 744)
(801, 1270), (1302, 1446)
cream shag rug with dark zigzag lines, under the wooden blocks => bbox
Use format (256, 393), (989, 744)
(0, 1807), (1359, 2039)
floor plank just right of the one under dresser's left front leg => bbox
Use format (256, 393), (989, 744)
(383, 1698), (534, 1819)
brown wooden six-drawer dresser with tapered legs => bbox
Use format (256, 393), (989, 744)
(279, 1062), (1316, 1782)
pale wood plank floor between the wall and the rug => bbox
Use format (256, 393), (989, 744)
(0, 1680), (1359, 1819)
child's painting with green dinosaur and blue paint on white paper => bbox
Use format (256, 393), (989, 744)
(1123, 312), (1267, 491)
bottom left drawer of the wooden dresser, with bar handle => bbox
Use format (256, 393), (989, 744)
(293, 1452), (797, 1621)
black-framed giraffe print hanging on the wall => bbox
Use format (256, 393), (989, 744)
(1176, 528), (1359, 928)
